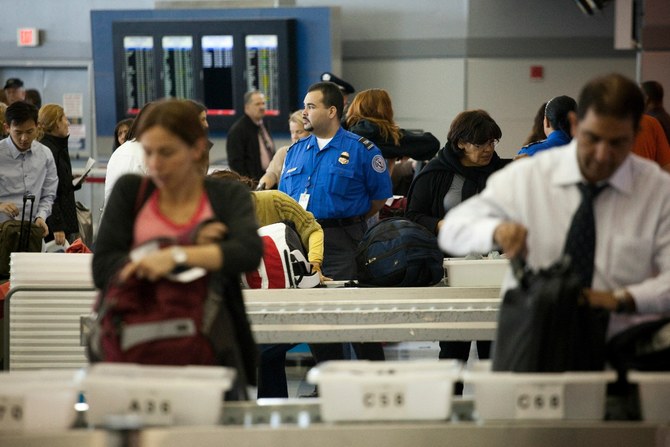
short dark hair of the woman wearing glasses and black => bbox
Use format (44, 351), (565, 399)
(446, 110), (502, 158)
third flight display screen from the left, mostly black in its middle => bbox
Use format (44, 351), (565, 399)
(202, 36), (235, 115)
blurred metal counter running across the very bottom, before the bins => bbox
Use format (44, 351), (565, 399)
(0, 399), (670, 447)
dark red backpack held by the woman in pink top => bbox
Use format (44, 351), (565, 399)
(89, 236), (226, 365)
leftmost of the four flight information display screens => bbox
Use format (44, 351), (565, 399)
(123, 36), (156, 115)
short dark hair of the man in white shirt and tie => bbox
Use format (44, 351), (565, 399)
(577, 73), (644, 132)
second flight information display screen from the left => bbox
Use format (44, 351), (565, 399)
(161, 36), (195, 99)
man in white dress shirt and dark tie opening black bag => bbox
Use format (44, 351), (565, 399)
(439, 74), (670, 336)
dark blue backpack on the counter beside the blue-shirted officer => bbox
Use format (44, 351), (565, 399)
(356, 217), (444, 287)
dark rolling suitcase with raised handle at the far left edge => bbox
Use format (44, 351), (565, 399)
(0, 193), (42, 279)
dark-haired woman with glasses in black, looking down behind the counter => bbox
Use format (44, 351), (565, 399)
(405, 110), (509, 380)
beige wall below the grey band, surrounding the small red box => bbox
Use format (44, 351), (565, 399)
(343, 58), (636, 157)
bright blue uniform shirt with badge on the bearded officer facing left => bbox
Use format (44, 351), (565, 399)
(279, 128), (393, 219)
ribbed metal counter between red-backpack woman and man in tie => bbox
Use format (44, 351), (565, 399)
(244, 287), (500, 343)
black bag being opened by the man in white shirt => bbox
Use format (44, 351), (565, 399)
(493, 258), (609, 372)
